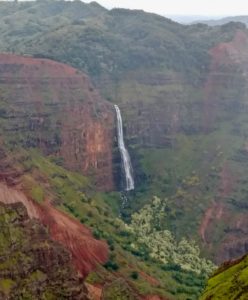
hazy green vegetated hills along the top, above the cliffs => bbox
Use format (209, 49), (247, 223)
(0, 0), (242, 80)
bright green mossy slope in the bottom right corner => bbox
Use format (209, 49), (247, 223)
(200, 256), (248, 300)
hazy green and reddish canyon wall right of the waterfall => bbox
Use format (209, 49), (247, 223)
(106, 29), (248, 263)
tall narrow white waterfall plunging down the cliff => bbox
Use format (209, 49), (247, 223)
(115, 105), (134, 191)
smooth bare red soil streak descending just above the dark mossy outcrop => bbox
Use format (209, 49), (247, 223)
(0, 183), (108, 276)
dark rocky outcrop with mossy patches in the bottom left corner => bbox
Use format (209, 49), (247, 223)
(0, 203), (88, 300)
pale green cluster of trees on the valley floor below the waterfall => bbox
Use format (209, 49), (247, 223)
(128, 197), (214, 274)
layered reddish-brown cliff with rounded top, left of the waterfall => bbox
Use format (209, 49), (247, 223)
(0, 54), (115, 190)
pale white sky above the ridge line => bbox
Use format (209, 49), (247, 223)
(83, 0), (248, 16)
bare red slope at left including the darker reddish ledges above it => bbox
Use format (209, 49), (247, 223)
(0, 145), (108, 277)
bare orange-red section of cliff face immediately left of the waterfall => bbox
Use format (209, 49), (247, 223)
(60, 97), (114, 190)
